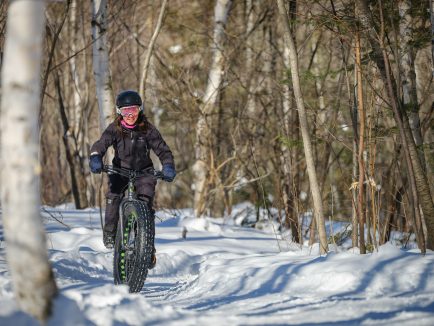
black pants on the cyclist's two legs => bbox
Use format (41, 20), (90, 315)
(104, 174), (157, 234)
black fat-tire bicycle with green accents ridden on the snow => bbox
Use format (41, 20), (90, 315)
(103, 165), (163, 293)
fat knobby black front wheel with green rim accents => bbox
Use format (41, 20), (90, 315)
(113, 200), (154, 293)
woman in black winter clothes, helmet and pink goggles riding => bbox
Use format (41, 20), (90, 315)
(89, 90), (176, 268)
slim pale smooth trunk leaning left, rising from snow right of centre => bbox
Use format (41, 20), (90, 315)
(277, 0), (328, 253)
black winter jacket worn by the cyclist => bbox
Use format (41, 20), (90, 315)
(90, 122), (175, 170)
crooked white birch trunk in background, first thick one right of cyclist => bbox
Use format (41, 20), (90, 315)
(193, 0), (232, 217)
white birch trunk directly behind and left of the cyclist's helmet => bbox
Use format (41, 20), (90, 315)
(92, 0), (115, 130)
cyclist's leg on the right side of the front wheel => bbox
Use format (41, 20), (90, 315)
(135, 177), (157, 269)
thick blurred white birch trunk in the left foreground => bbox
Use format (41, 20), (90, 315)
(0, 0), (57, 322)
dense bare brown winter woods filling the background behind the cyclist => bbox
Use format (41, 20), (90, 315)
(0, 0), (434, 252)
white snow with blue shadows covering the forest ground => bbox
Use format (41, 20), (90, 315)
(0, 204), (434, 326)
